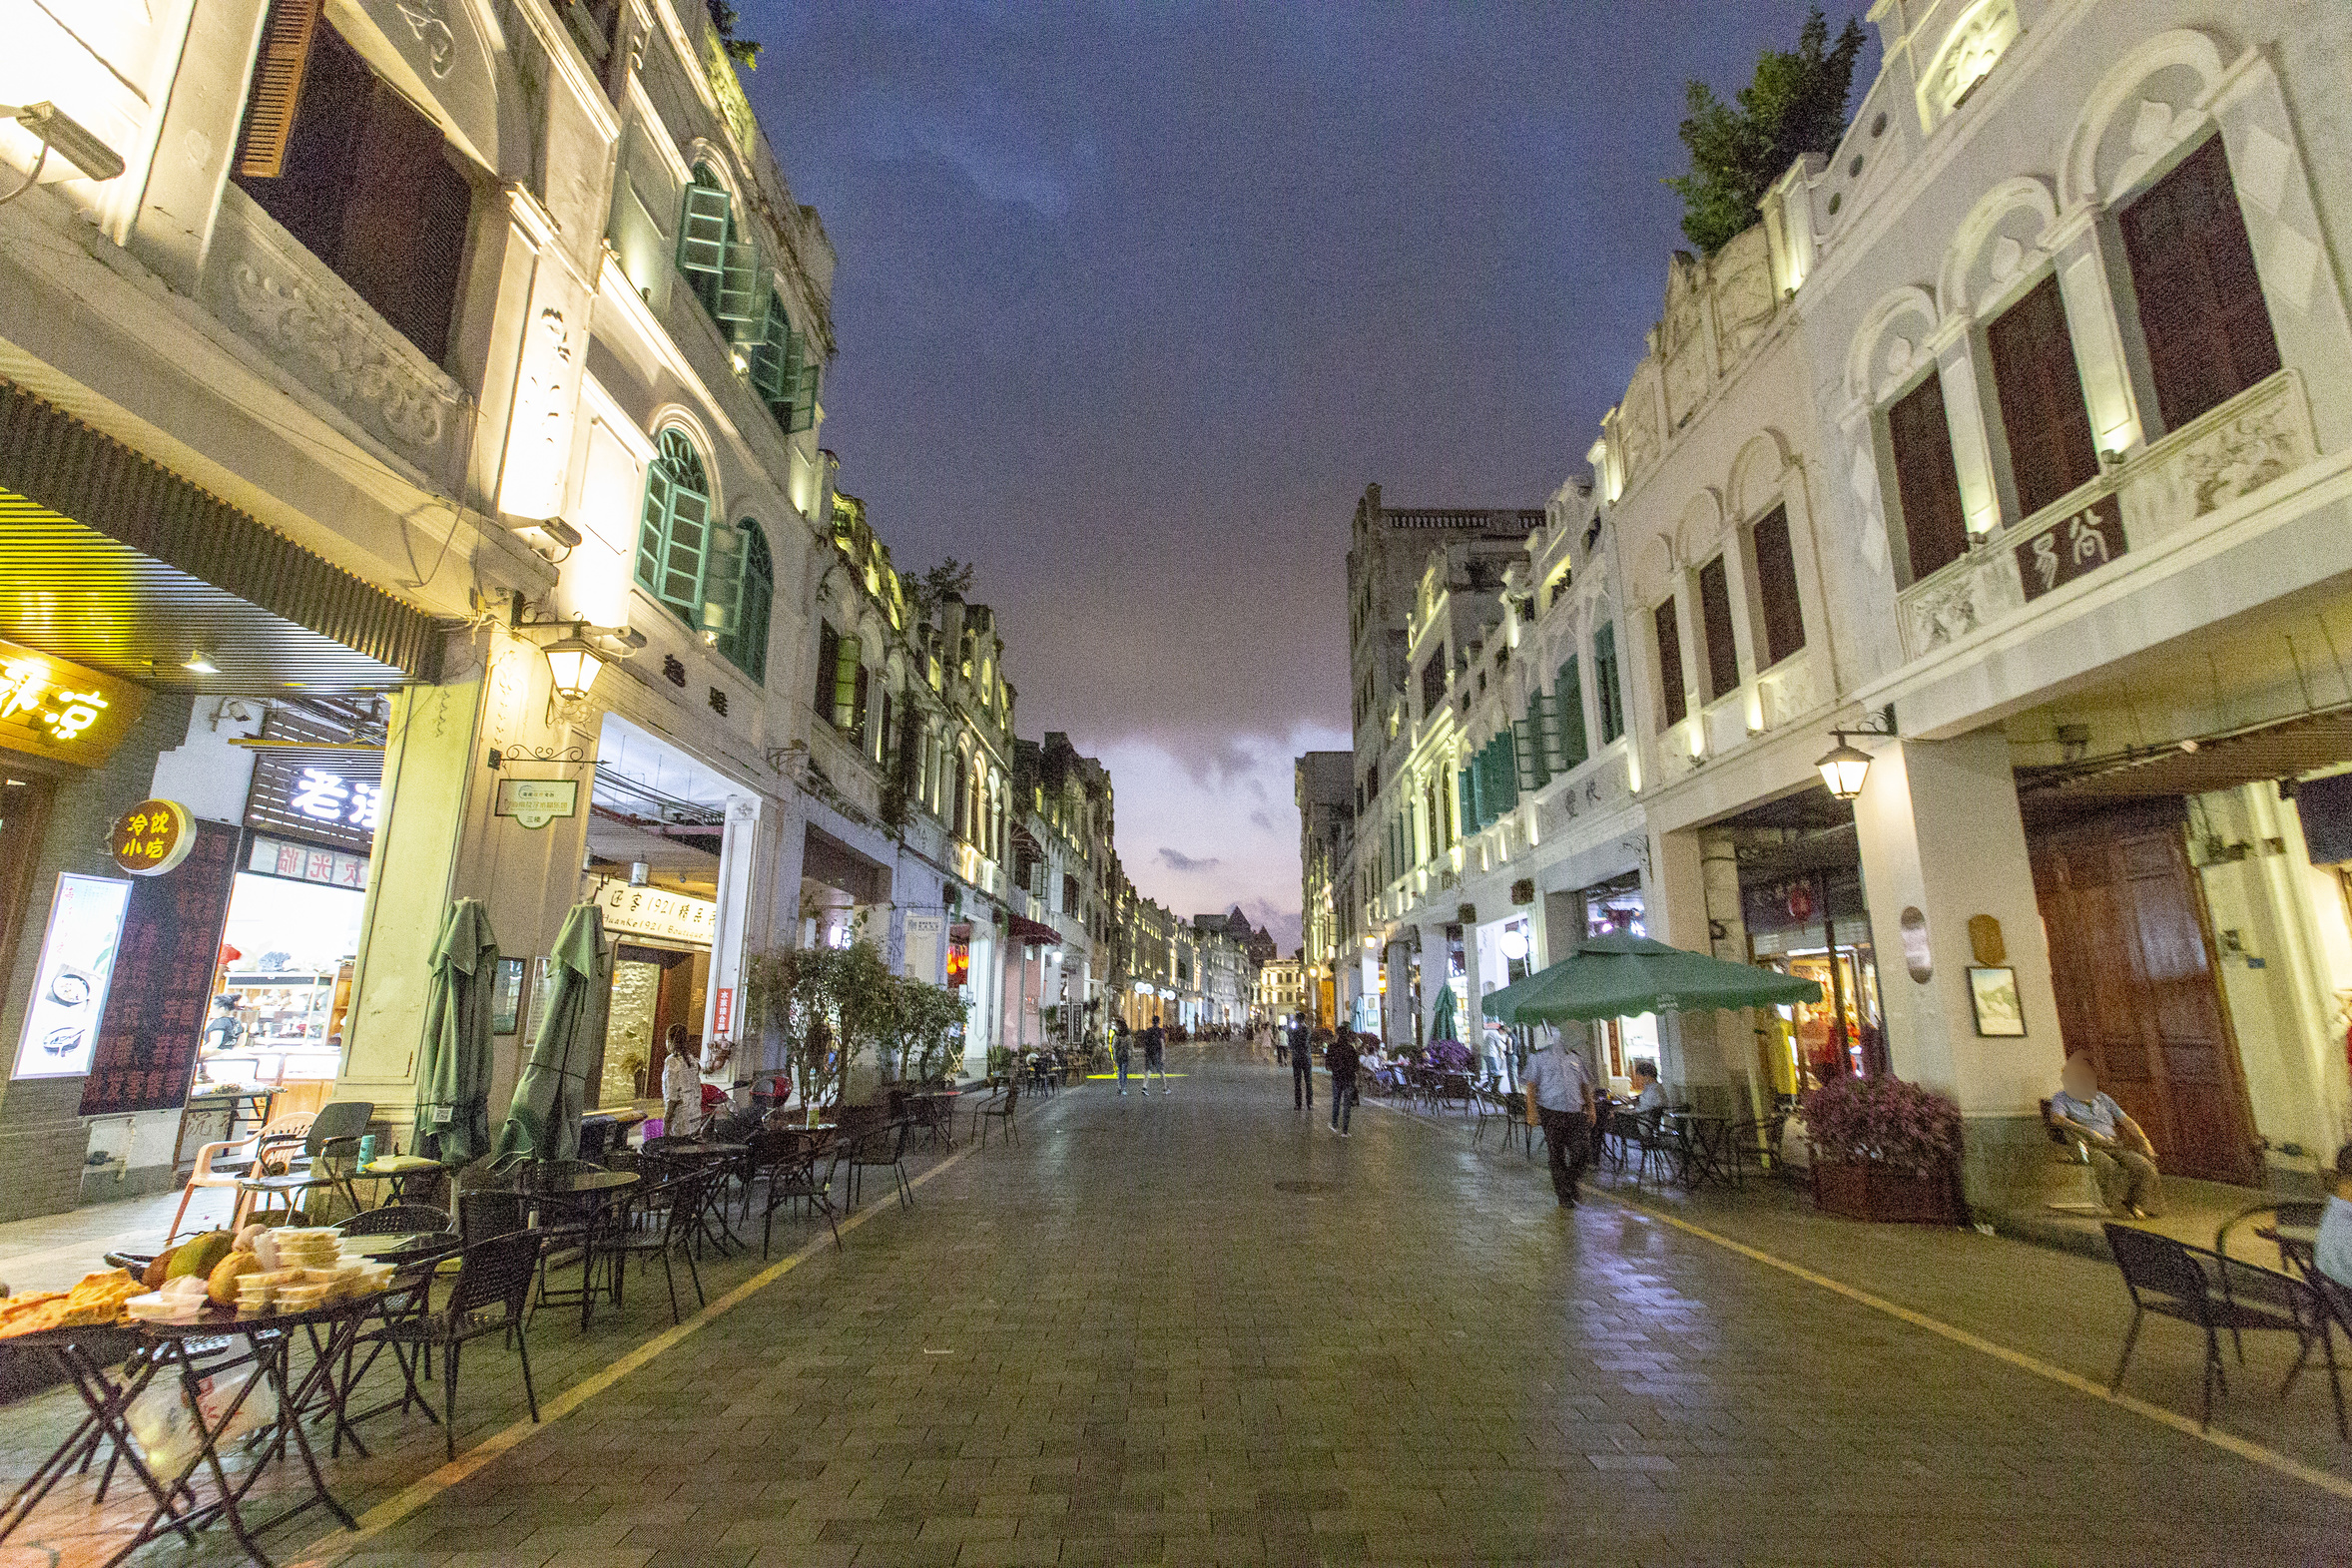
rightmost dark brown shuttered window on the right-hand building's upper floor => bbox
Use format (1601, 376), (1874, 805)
(2119, 137), (2279, 430)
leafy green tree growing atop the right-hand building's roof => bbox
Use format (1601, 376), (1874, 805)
(1665, 5), (1863, 254)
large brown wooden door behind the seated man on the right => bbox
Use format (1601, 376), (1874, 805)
(2033, 801), (2258, 1183)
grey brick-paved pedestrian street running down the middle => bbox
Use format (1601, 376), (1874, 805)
(0, 1048), (2352, 1568)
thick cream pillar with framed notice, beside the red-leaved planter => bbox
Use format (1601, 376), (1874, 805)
(1854, 724), (2065, 1209)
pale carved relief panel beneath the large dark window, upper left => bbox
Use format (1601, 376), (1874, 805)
(207, 188), (458, 475)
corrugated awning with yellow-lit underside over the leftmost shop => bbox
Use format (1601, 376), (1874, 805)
(0, 381), (442, 691)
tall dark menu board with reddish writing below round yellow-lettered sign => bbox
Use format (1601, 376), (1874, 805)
(80, 822), (238, 1117)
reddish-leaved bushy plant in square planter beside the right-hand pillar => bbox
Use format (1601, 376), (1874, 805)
(1799, 1074), (1962, 1225)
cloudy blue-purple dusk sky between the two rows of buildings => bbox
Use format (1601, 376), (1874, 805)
(739, 0), (1875, 950)
